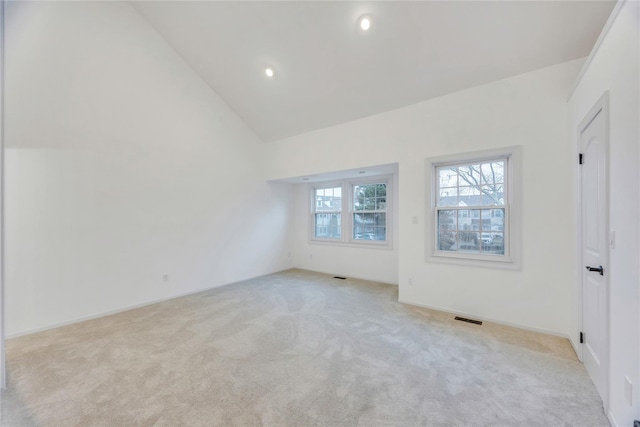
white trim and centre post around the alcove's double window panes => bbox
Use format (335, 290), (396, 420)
(308, 175), (395, 249)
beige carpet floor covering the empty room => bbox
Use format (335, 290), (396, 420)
(1, 270), (609, 427)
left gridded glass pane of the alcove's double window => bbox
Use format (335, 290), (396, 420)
(313, 187), (342, 239)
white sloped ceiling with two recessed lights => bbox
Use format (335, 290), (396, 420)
(132, 0), (615, 142)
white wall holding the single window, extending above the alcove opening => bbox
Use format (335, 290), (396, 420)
(267, 60), (583, 335)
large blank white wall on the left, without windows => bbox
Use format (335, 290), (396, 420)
(5, 2), (293, 336)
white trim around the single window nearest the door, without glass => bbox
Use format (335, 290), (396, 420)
(425, 146), (522, 270)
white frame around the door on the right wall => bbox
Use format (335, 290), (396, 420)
(576, 91), (611, 414)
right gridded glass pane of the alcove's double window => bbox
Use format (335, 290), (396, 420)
(352, 182), (387, 241)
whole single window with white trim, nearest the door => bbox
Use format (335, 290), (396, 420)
(427, 148), (519, 265)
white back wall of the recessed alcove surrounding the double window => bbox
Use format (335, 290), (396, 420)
(292, 170), (398, 284)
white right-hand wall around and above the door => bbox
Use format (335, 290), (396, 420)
(569, 1), (640, 426)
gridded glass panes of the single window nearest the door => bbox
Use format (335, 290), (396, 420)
(435, 158), (509, 257)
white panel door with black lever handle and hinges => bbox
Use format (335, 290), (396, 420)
(579, 98), (609, 407)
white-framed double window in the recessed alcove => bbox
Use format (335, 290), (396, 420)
(311, 177), (390, 245)
